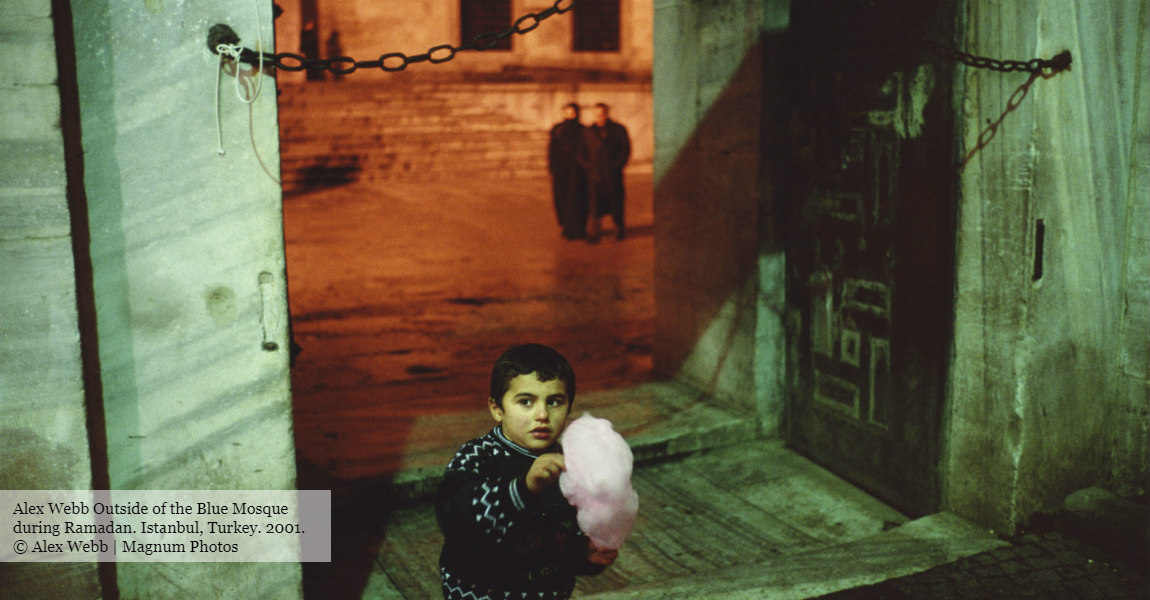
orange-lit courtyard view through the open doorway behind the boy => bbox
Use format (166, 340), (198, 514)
(270, 0), (654, 483)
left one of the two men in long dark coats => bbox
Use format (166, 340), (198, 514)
(547, 102), (587, 239)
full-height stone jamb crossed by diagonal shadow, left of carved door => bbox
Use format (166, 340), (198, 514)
(653, 0), (787, 433)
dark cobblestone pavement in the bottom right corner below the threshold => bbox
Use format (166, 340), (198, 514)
(820, 519), (1150, 600)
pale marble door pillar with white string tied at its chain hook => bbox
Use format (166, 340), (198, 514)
(72, 0), (300, 598)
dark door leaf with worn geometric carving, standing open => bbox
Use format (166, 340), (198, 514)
(787, 0), (956, 514)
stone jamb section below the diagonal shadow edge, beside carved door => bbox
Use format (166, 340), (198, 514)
(654, 34), (783, 410)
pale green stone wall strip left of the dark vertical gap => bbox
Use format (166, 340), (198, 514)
(0, 0), (100, 598)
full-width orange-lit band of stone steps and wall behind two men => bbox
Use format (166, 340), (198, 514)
(279, 74), (654, 193)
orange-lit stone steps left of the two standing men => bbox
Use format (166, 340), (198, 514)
(279, 80), (547, 193)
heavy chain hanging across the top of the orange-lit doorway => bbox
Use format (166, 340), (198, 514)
(227, 0), (576, 75)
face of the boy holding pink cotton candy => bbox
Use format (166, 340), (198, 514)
(488, 372), (570, 452)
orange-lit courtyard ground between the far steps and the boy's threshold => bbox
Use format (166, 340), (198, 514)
(284, 160), (654, 479)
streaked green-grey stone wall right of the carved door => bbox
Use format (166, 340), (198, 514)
(944, 0), (1150, 531)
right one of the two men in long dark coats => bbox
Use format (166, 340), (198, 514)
(580, 102), (631, 243)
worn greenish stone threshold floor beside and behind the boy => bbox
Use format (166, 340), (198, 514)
(361, 436), (1006, 600)
